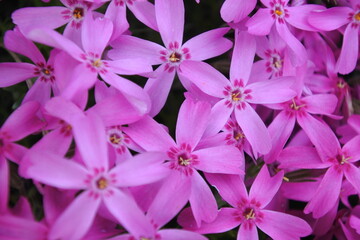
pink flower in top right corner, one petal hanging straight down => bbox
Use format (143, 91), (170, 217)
(308, 0), (360, 74)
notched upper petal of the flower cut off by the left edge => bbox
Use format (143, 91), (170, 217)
(1, 102), (44, 141)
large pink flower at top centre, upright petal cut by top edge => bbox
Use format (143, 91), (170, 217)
(108, 0), (232, 116)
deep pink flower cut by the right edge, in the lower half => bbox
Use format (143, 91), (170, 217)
(279, 136), (360, 218)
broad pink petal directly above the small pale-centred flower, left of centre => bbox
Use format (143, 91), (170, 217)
(88, 93), (148, 127)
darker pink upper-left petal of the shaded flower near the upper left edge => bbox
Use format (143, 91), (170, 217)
(4, 27), (45, 64)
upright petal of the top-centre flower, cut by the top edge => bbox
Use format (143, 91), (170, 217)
(155, 0), (185, 48)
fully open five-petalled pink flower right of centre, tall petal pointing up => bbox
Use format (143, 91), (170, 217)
(181, 32), (295, 154)
